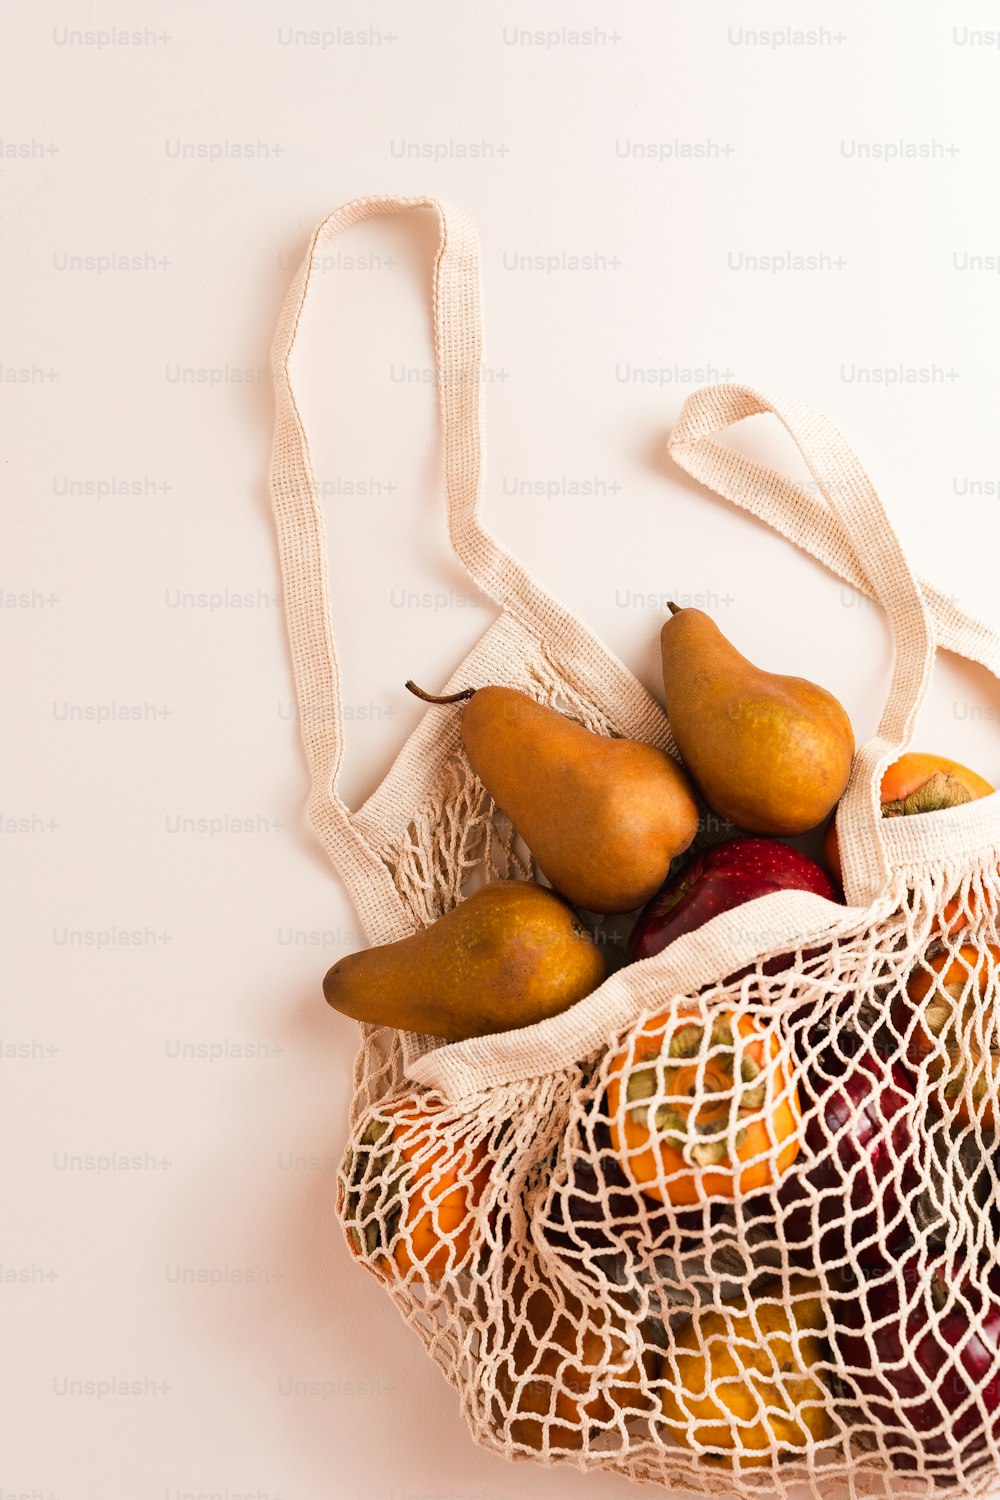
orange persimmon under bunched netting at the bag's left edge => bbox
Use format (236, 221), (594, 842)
(339, 1100), (492, 1281)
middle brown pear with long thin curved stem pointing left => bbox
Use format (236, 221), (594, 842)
(408, 684), (699, 912)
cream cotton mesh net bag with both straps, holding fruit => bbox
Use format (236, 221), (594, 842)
(273, 198), (1000, 1496)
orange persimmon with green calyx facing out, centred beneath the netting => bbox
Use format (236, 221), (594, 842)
(607, 1008), (801, 1208)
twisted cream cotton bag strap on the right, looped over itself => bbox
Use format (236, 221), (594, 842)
(669, 386), (941, 906)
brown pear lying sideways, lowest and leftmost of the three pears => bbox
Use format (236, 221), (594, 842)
(322, 881), (606, 1041)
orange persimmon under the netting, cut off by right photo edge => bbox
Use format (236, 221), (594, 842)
(898, 944), (1000, 1130)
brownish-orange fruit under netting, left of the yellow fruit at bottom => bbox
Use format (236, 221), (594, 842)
(493, 1278), (649, 1452)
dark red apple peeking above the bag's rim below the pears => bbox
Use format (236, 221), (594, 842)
(628, 839), (837, 974)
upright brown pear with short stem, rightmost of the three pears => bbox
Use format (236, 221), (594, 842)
(660, 605), (855, 836)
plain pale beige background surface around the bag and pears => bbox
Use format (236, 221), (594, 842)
(0, 0), (1000, 1500)
